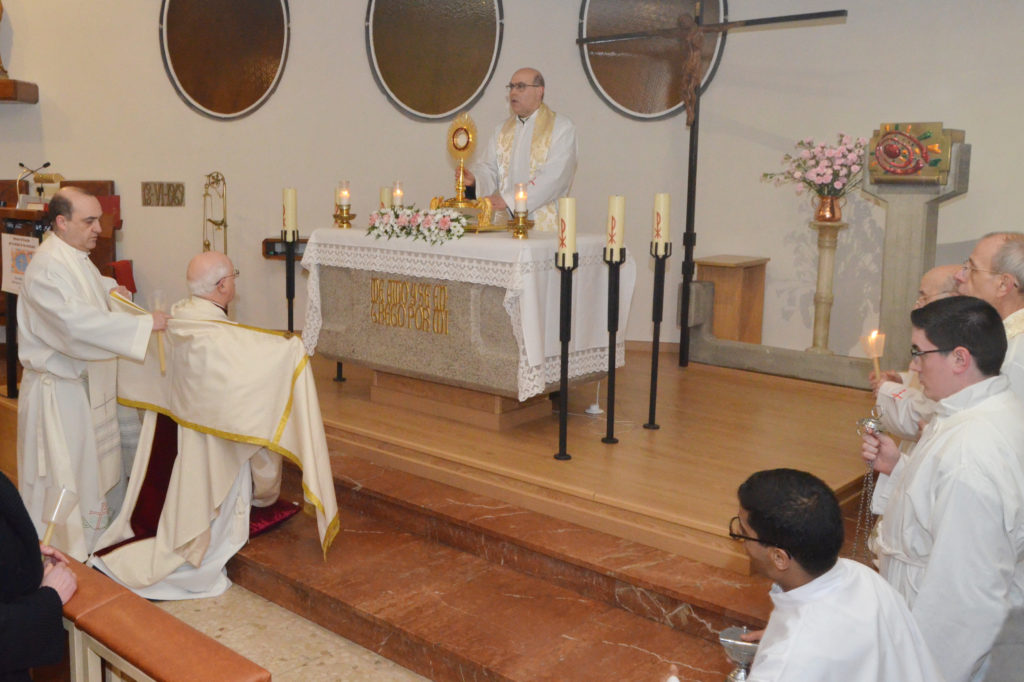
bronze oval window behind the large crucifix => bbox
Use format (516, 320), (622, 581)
(579, 0), (727, 120)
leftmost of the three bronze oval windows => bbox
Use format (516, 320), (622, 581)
(160, 0), (290, 120)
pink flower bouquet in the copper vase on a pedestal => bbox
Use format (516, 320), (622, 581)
(761, 133), (867, 197)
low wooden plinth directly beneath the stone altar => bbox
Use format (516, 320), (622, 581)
(370, 372), (551, 431)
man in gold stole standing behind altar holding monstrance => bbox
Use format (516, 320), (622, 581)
(465, 69), (579, 231)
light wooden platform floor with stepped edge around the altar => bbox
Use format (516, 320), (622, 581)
(314, 351), (871, 572)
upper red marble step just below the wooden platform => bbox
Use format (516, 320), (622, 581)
(333, 456), (771, 643)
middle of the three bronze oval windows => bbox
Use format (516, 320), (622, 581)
(366, 0), (504, 120)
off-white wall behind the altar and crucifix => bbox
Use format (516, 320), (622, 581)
(0, 0), (1024, 354)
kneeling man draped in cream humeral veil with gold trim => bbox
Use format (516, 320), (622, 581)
(90, 252), (338, 599)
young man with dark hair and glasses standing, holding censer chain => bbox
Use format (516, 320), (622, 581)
(861, 296), (1024, 682)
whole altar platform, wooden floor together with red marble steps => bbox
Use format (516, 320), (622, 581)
(229, 351), (871, 680)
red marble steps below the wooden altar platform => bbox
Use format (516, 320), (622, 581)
(229, 456), (769, 680)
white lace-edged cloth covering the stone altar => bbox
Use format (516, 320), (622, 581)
(302, 227), (636, 400)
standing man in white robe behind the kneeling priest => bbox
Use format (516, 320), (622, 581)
(17, 187), (167, 561)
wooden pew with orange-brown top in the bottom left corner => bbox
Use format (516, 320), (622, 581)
(63, 560), (270, 682)
